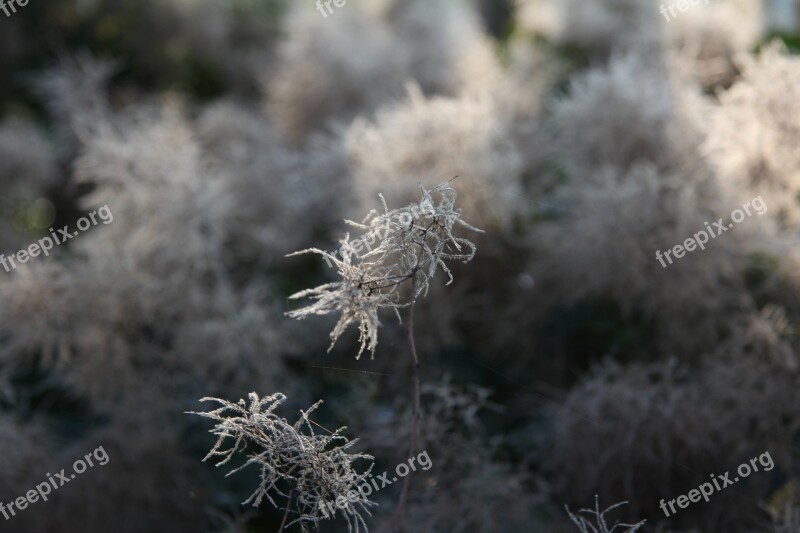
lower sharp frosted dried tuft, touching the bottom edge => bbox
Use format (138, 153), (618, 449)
(193, 392), (376, 532)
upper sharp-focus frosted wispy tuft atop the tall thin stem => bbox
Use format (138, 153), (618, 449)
(287, 182), (482, 359)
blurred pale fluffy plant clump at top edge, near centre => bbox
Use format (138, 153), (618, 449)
(265, 0), (500, 144)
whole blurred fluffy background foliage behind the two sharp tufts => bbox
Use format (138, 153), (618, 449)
(0, 0), (800, 533)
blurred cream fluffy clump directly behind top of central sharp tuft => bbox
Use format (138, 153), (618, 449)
(345, 84), (530, 231)
